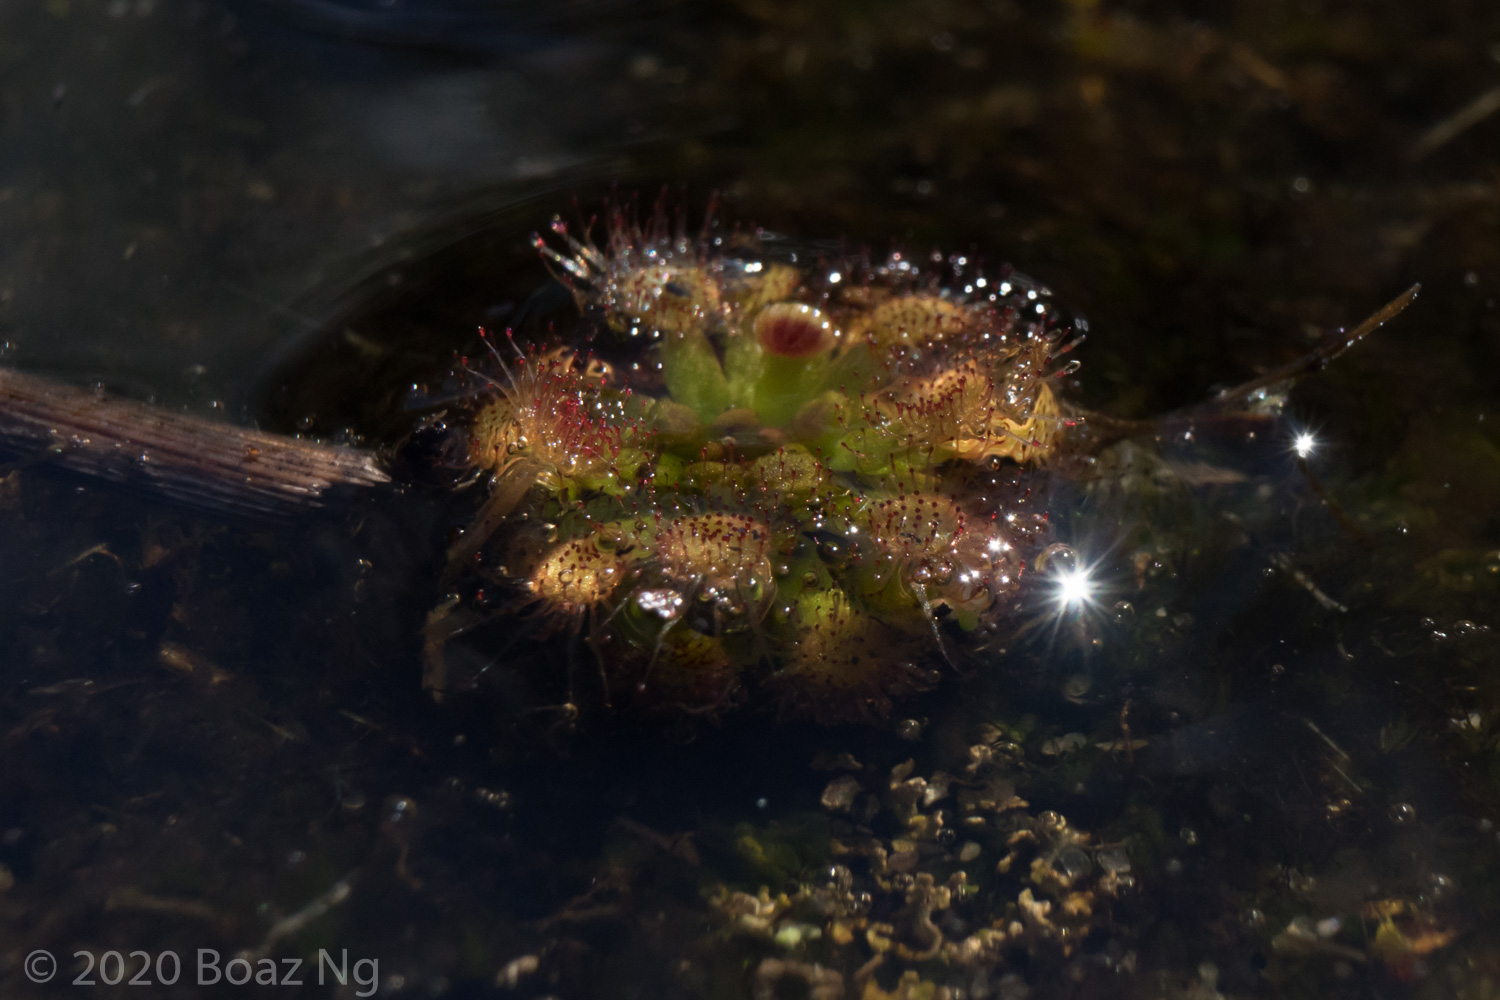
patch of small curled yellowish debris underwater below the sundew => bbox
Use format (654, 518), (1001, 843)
(716, 747), (1134, 997)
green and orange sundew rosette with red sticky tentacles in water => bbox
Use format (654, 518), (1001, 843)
(429, 203), (1077, 723)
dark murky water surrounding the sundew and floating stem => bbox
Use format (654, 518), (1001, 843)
(0, 0), (1500, 999)
